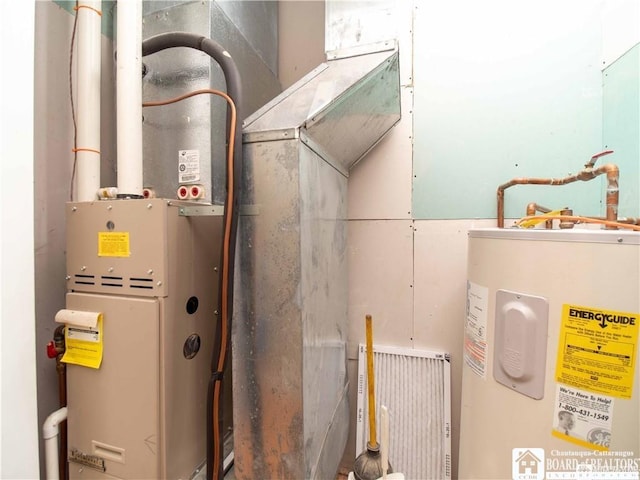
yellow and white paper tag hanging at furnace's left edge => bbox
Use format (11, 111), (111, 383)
(62, 314), (103, 368)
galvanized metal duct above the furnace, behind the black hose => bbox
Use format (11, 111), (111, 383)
(143, 1), (282, 205)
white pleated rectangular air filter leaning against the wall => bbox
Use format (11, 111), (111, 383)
(356, 345), (451, 480)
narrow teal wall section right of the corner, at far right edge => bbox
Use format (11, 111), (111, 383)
(602, 44), (640, 217)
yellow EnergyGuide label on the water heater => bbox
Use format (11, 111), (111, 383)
(556, 304), (640, 398)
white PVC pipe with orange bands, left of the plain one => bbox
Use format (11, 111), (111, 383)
(76, 0), (102, 202)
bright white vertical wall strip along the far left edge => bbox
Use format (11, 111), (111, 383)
(0, 2), (38, 479)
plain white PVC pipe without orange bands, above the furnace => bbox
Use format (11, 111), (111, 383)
(116, 0), (142, 195)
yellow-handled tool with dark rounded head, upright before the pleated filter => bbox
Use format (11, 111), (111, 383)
(353, 315), (391, 480)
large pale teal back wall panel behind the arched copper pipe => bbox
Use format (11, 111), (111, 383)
(412, 0), (613, 219)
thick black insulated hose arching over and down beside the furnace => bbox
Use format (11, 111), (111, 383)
(142, 32), (242, 480)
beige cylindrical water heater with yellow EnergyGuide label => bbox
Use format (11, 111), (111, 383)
(459, 228), (640, 480)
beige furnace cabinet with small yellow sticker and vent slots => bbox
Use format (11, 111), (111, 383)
(66, 199), (222, 479)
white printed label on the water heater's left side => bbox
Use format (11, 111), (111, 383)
(464, 281), (489, 378)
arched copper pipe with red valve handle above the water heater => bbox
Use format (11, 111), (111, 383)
(497, 150), (620, 230)
